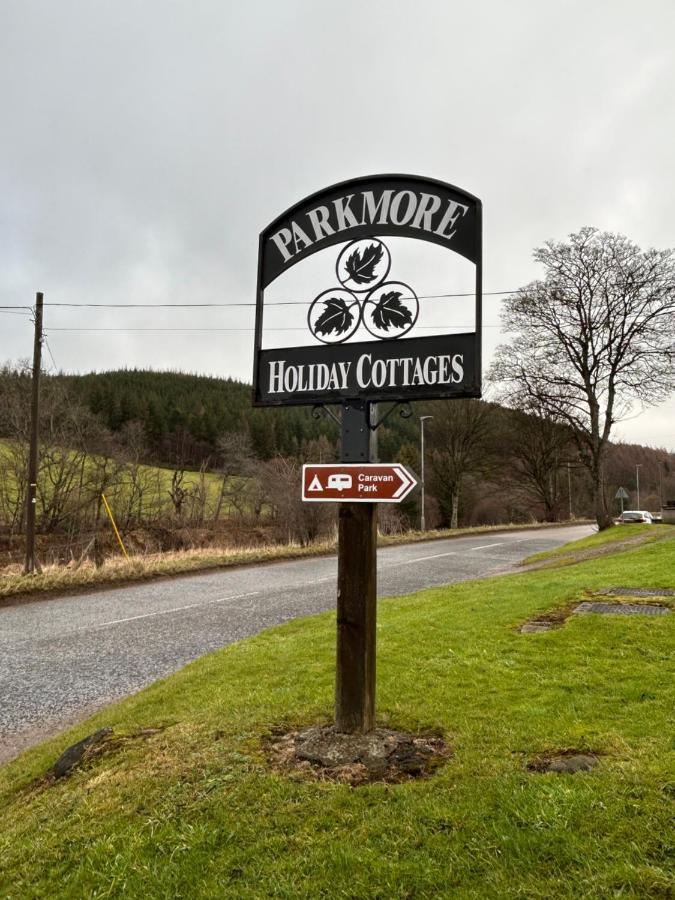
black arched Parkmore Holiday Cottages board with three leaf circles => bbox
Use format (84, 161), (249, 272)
(253, 175), (482, 406)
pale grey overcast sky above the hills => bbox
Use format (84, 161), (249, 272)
(0, 0), (675, 450)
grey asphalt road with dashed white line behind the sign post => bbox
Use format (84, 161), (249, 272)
(0, 525), (592, 761)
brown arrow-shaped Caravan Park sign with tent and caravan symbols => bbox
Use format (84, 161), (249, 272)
(302, 463), (417, 503)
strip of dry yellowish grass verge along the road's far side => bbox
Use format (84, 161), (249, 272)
(0, 523), (592, 603)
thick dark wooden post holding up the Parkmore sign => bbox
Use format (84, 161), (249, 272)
(335, 401), (377, 734)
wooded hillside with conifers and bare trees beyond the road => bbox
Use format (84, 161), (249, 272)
(0, 366), (675, 556)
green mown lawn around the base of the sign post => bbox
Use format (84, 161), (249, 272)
(0, 534), (675, 900)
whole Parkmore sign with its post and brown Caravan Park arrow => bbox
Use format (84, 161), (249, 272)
(253, 175), (482, 733)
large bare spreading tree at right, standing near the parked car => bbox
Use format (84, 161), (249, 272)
(489, 228), (675, 529)
